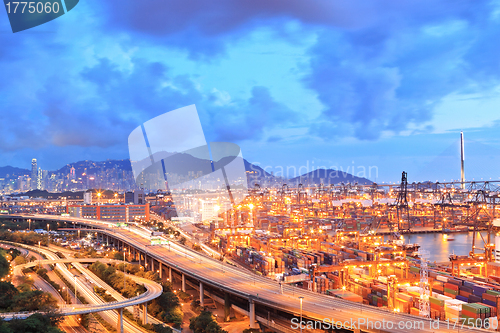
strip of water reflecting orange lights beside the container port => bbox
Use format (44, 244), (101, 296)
(404, 232), (495, 262)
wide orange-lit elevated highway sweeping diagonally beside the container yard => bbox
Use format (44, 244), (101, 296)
(1, 215), (486, 333)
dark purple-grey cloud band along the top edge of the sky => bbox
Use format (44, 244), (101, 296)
(93, 0), (492, 59)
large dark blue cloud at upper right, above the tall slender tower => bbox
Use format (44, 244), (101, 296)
(304, 1), (500, 140)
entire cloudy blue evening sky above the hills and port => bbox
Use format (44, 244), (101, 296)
(0, 0), (500, 183)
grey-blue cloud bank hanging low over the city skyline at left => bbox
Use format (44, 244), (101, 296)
(0, 50), (295, 157)
